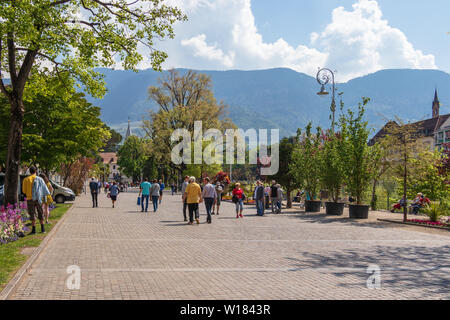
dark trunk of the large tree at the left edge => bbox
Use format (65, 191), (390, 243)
(4, 91), (24, 204)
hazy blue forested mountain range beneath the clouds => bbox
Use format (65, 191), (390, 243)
(88, 68), (450, 137)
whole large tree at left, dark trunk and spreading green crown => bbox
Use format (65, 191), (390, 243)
(0, 0), (186, 203)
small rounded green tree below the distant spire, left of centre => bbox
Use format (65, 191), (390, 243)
(117, 136), (149, 181)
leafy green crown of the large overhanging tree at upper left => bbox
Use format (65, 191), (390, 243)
(0, 0), (186, 97)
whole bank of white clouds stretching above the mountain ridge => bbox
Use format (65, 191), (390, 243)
(141, 0), (436, 81)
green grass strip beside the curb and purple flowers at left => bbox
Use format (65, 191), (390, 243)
(0, 204), (72, 291)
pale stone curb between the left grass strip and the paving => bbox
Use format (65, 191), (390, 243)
(0, 204), (75, 300)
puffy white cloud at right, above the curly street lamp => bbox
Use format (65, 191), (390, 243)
(311, 0), (436, 81)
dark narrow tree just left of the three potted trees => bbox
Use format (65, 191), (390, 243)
(272, 137), (300, 208)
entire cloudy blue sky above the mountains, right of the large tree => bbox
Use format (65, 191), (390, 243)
(140, 0), (450, 82)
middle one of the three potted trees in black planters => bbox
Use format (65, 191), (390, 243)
(319, 130), (344, 216)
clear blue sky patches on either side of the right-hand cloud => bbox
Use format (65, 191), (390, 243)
(251, 0), (450, 72)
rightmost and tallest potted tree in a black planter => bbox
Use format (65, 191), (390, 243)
(340, 98), (373, 219)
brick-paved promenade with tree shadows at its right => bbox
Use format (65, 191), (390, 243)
(7, 192), (450, 299)
